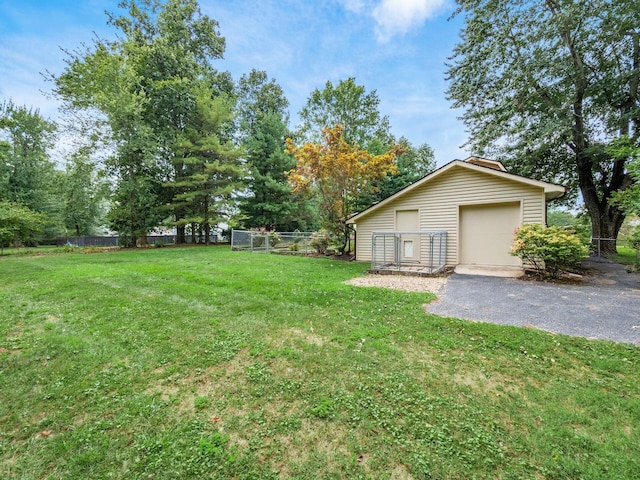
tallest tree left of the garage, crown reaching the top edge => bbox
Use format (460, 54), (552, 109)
(109, 0), (233, 243)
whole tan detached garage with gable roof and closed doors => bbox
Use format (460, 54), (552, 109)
(347, 157), (566, 272)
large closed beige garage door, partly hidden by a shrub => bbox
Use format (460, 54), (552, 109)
(459, 202), (522, 267)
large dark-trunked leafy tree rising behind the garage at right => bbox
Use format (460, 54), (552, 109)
(447, 0), (640, 253)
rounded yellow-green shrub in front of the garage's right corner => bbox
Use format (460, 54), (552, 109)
(510, 224), (589, 278)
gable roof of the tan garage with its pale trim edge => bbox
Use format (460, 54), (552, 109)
(347, 157), (567, 224)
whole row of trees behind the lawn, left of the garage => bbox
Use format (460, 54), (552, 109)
(0, 0), (433, 246)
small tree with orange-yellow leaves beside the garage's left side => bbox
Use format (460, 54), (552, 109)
(287, 125), (402, 253)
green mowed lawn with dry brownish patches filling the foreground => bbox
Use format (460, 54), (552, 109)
(0, 247), (640, 479)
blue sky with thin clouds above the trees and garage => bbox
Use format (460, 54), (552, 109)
(0, 0), (469, 165)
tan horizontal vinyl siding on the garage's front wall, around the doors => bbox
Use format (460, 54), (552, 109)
(356, 167), (546, 265)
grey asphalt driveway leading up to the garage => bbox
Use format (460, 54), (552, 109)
(428, 259), (640, 345)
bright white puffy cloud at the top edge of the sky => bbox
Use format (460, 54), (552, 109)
(372, 0), (449, 42)
